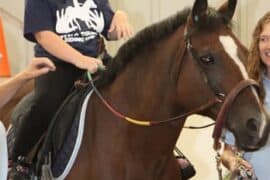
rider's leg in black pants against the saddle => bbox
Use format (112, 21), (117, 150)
(8, 61), (83, 179)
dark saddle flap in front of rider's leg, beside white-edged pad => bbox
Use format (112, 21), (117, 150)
(35, 75), (92, 176)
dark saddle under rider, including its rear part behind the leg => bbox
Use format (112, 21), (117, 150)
(7, 75), (92, 179)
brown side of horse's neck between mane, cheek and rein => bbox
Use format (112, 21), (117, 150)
(104, 27), (187, 120)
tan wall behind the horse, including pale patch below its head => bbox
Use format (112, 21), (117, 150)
(0, 0), (270, 180)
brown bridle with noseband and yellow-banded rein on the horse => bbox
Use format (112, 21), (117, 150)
(87, 19), (259, 150)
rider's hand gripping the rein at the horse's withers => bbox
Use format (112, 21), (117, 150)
(75, 55), (104, 73)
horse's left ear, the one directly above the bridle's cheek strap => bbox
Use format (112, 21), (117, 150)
(191, 0), (208, 24)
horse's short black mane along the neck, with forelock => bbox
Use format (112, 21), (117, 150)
(96, 8), (229, 87)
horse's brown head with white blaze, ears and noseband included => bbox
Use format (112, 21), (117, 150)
(176, 0), (269, 150)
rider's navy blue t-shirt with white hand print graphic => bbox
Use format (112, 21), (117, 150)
(24, 0), (114, 57)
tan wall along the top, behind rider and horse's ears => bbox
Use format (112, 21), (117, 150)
(0, 0), (270, 73)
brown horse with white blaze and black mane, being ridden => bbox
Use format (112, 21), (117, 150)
(63, 0), (269, 180)
